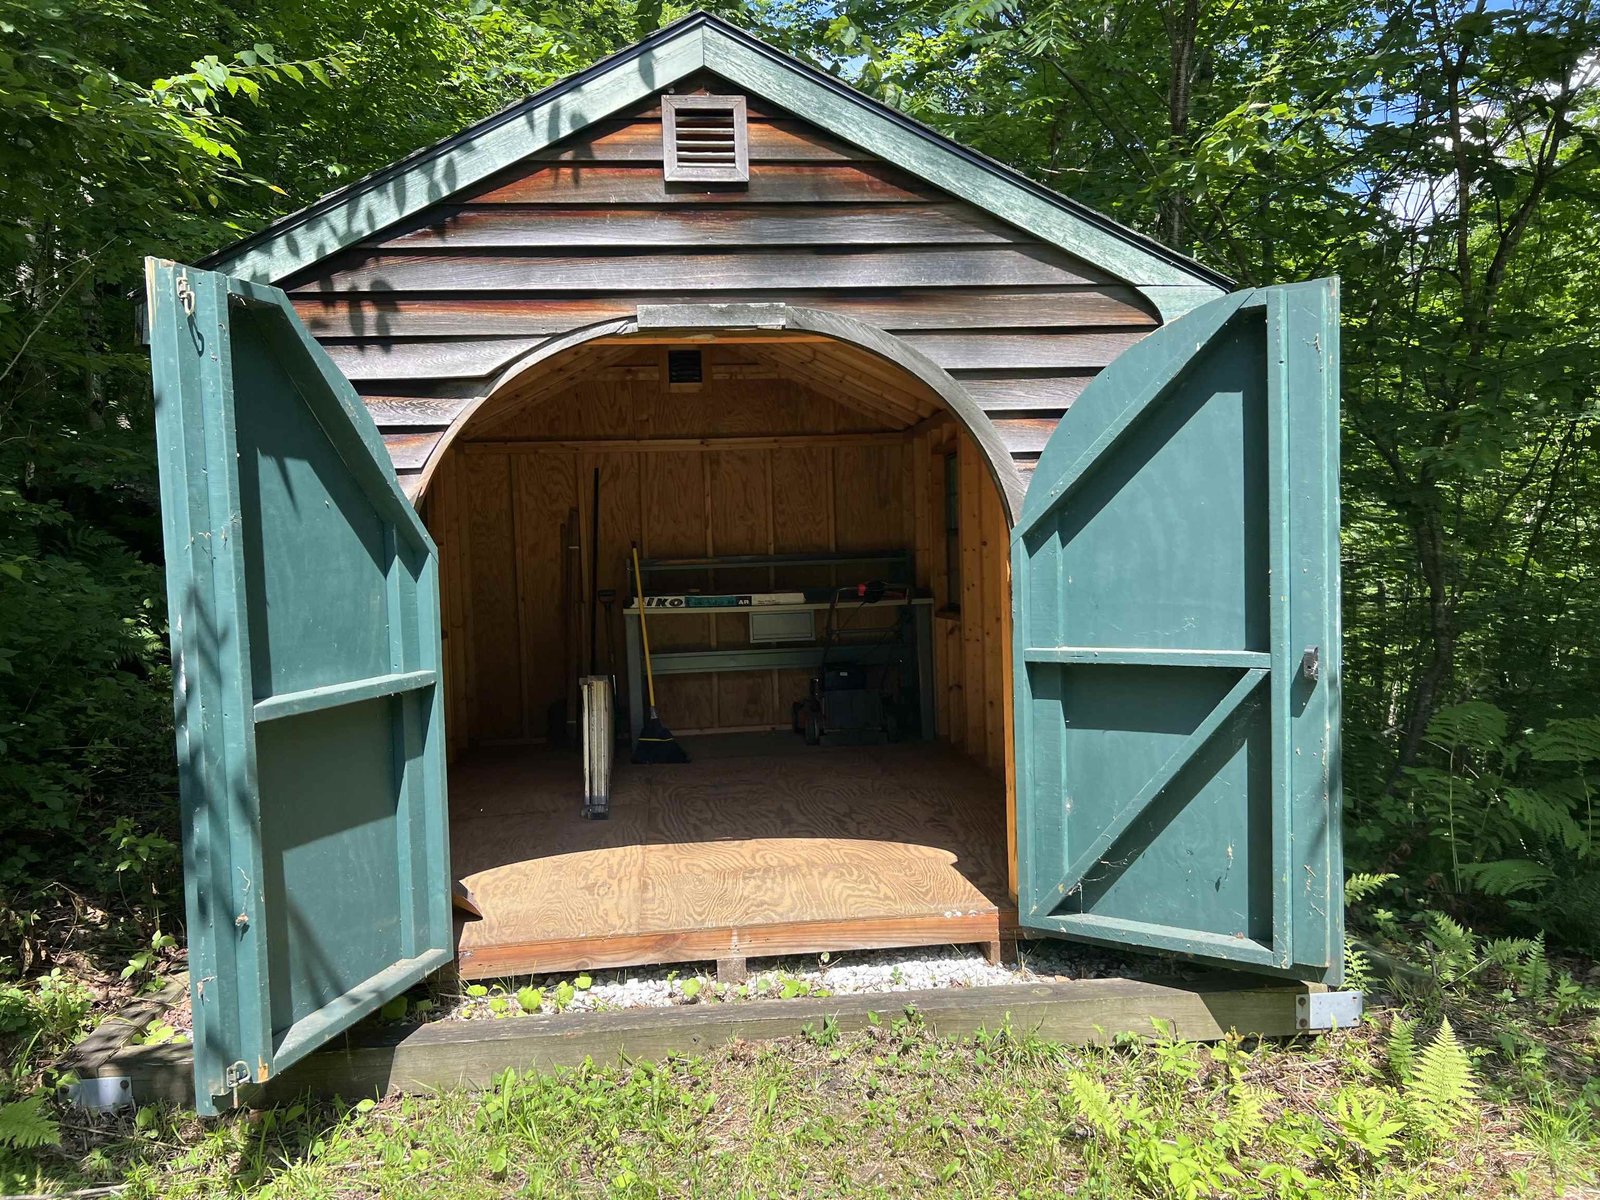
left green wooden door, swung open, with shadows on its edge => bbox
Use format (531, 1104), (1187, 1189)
(146, 259), (453, 1112)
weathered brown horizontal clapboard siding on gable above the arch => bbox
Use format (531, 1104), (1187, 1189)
(286, 77), (1158, 491)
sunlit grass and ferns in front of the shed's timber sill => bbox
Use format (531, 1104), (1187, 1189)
(12, 1014), (1600, 1200)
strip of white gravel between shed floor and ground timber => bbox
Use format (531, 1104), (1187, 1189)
(438, 941), (1182, 1021)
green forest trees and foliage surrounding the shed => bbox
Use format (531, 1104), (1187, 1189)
(0, 0), (1600, 970)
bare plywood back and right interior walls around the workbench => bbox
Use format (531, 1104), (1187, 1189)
(426, 346), (1011, 876)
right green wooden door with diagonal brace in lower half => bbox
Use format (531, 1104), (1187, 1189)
(1011, 280), (1342, 982)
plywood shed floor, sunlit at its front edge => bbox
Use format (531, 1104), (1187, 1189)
(450, 734), (1014, 978)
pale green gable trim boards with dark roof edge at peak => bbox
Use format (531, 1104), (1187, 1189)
(198, 13), (1229, 320)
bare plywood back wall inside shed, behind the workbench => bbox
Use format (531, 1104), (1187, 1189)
(426, 350), (912, 752)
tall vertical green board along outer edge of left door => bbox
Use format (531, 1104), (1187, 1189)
(144, 259), (272, 1104)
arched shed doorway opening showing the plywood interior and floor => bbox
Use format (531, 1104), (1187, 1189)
(424, 315), (1019, 976)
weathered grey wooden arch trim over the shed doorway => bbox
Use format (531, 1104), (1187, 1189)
(413, 304), (1026, 526)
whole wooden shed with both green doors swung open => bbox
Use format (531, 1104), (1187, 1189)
(147, 14), (1342, 1106)
